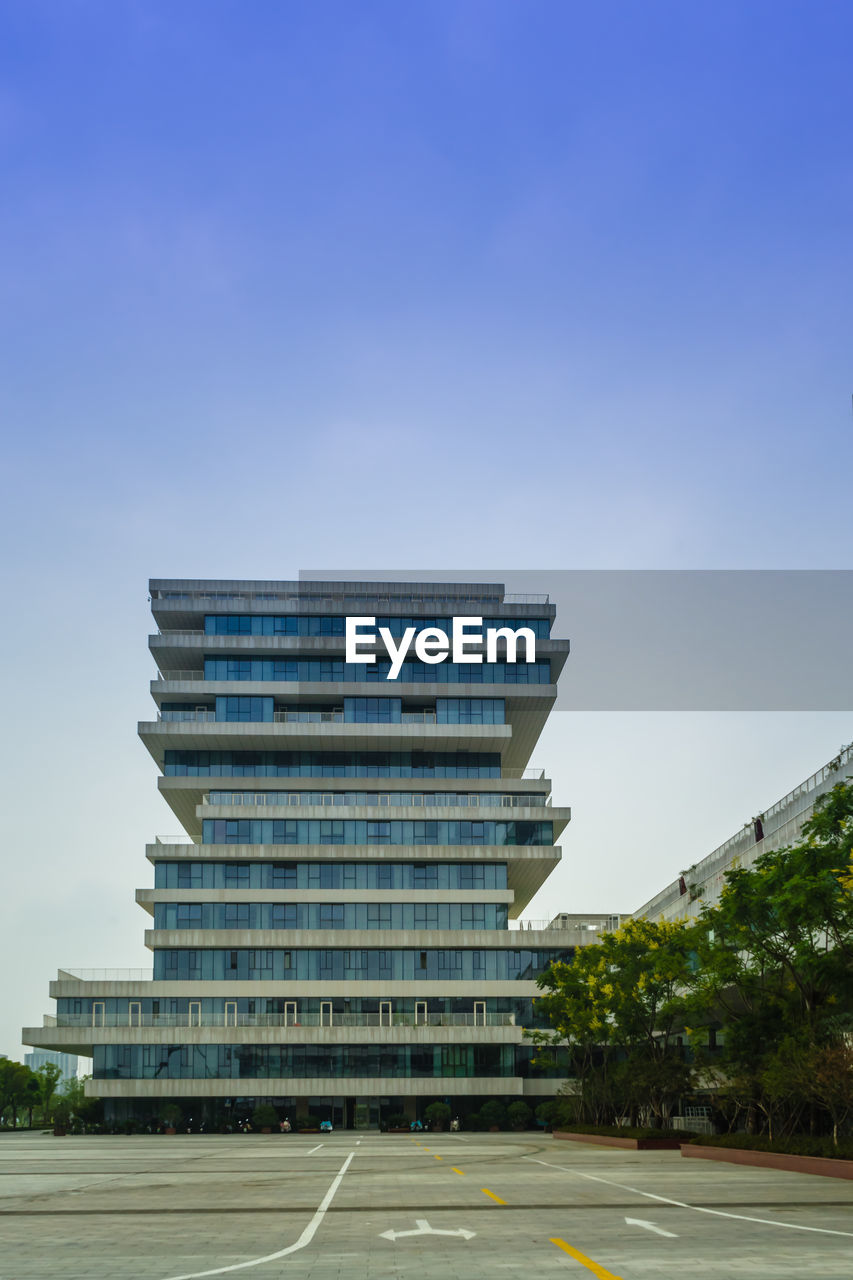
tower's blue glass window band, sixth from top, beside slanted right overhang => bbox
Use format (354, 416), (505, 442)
(154, 859), (507, 890)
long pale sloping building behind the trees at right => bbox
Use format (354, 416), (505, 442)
(633, 746), (853, 920)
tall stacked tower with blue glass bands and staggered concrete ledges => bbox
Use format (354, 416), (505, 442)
(23, 580), (597, 1128)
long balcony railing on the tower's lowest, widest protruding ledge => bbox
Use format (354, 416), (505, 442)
(55, 1012), (515, 1029)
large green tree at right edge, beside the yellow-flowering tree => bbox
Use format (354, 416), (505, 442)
(688, 782), (853, 1135)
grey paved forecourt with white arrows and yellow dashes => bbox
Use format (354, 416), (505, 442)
(0, 1133), (853, 1280)
